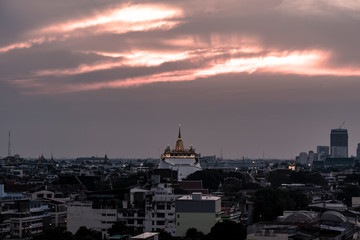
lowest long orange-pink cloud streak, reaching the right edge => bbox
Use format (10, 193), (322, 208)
(23, 47), (360, 93)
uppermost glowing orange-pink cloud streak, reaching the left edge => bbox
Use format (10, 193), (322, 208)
(0, 5), (183, 53)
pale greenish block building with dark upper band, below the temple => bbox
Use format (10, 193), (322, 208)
(175, 193), (221, 237)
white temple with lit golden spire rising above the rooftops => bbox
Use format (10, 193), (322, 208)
(159, 126), (201, 181)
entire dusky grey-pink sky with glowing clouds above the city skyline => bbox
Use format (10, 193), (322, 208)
(0, 0), (360, 159)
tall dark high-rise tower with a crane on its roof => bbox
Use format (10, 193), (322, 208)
(330, 128), (348, 158)
